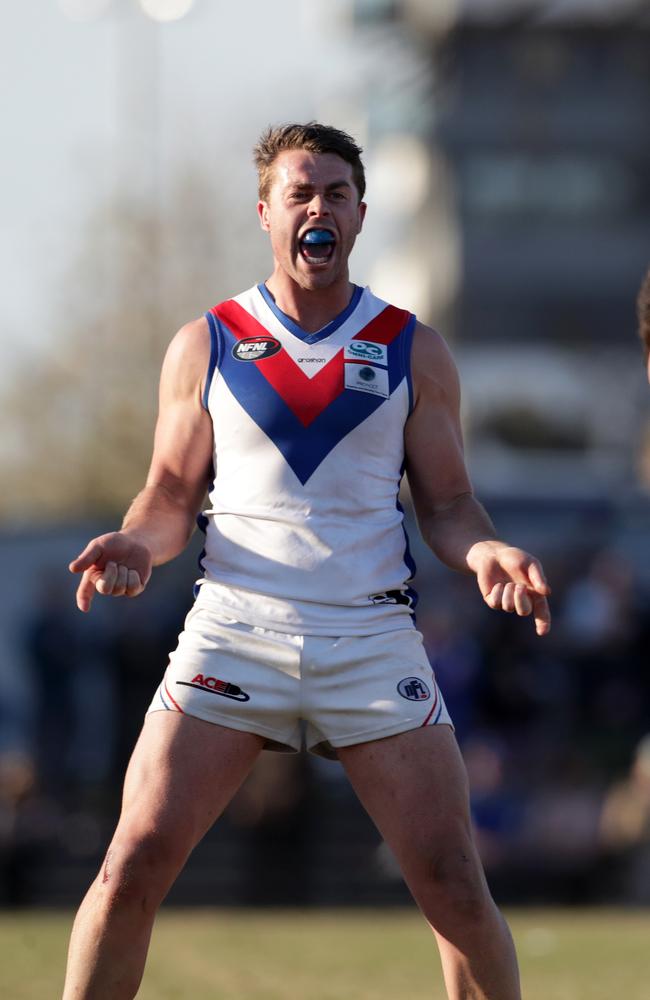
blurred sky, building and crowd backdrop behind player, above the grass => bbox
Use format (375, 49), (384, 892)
(0, 0), (650, 906)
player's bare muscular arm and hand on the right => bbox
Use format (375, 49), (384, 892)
(405, 324), (550, 635)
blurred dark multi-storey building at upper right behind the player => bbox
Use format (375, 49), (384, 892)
(344, 0), (650, 498)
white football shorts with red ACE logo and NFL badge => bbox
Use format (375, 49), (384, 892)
(148, 606), (451, 759)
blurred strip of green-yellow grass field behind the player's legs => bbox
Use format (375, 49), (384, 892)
(0, 909), (650, 1000)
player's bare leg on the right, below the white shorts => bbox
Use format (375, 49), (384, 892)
(339, 726), (521, 1000)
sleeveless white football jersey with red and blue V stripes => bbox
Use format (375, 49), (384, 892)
(197, 285), (416, 636)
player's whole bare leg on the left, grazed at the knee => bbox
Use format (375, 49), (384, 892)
(63, 712), (264, 1000)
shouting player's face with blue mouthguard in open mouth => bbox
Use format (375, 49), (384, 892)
(257, 149), (366, 289)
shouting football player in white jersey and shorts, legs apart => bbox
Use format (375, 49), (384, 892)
(64, 123), (550, 1000)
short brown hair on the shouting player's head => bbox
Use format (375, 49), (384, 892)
(253, 122), (366, 201)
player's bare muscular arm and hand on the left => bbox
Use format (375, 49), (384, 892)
(70, 319), (212, 611)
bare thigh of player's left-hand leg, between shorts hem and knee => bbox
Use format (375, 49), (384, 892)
(117, 712), (264, 851)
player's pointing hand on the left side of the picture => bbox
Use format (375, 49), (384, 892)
(70, 531), (152, 611)
